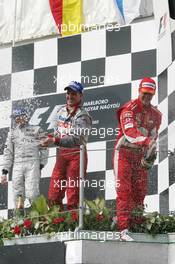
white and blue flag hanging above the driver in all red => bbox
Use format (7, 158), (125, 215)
(115, 0), (141, 25)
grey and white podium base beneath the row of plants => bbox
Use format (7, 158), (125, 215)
(0, 231), (175, 264)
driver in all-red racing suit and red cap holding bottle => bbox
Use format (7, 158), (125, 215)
(113, 77), (161, 240)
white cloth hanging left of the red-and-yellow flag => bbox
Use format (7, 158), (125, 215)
(0, 0), (58, 43)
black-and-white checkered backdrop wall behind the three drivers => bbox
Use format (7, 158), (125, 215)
(0, 19), (175, 218)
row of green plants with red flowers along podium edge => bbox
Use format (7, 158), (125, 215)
(0, 196), (175, 245)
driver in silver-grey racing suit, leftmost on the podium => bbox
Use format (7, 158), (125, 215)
(1, 108), (48, 209)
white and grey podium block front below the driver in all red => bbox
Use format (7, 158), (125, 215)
(66, 237), (175, 264)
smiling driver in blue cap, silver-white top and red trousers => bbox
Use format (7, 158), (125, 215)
(42, 82), (91, 210)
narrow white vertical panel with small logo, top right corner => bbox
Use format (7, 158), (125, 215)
(152, 0), (172, 75)
